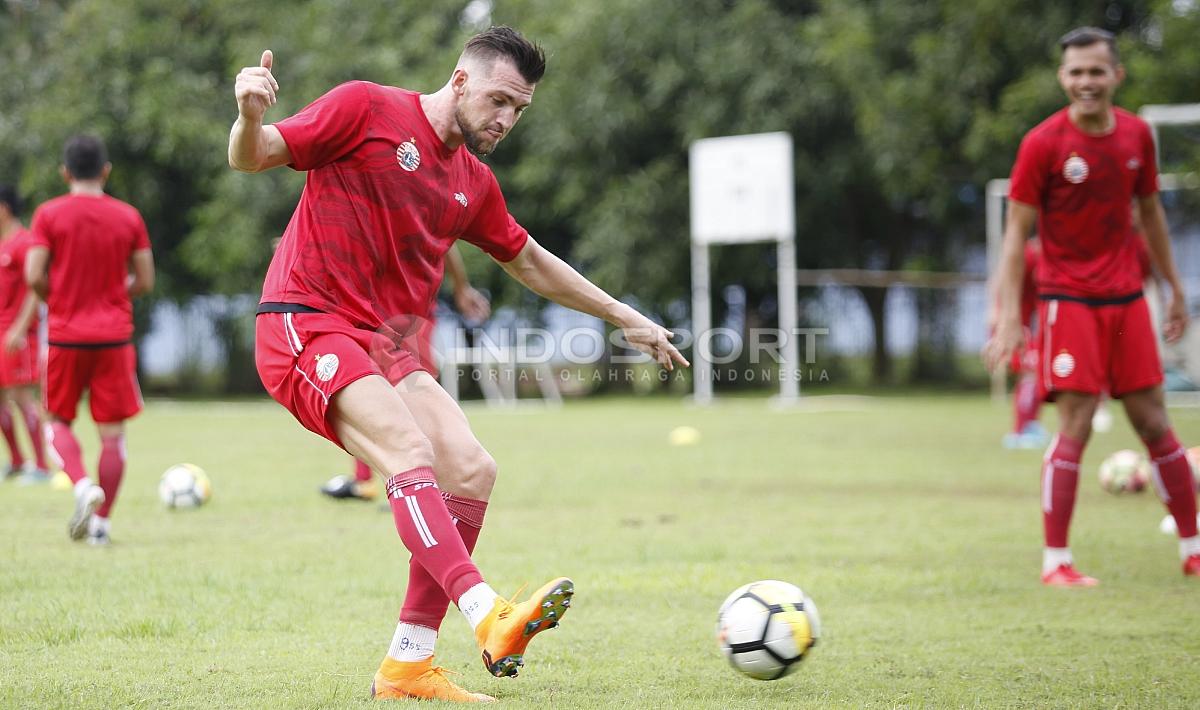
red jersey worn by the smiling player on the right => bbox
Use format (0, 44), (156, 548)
(1008, 108), (1158, 299)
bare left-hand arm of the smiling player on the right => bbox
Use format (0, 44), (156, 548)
(983, 199), (1038, 371)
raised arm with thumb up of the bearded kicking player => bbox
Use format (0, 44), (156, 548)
(229, 49), (292, 173)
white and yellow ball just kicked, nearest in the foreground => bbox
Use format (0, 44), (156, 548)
(716, 579), (821, 680)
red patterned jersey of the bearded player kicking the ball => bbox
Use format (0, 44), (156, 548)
(263, 82), (528, 330)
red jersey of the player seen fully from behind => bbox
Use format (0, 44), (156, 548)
(31, 194), (150, 345)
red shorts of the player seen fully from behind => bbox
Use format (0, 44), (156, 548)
(42, 343), (142, 423)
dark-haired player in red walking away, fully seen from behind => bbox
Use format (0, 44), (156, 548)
(25, 136), (154, 544)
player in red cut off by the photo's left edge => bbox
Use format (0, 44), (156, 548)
(0, 185), (50, 483)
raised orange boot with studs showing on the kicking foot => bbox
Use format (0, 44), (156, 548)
(475, 577), (575, 678)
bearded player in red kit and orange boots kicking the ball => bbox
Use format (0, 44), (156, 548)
(229, 28), (686, 702)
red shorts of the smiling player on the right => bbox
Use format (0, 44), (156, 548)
(1039, 297), (1163, 399)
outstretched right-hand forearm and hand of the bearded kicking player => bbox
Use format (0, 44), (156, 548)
(499, 236), (689, 369)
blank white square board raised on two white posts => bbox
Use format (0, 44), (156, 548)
(689, 133), (796, 245)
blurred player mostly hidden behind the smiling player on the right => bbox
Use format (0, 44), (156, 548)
(1003, 236), (1046, 449)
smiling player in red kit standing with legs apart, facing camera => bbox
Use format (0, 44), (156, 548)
(984, 28), (1200, 586)
